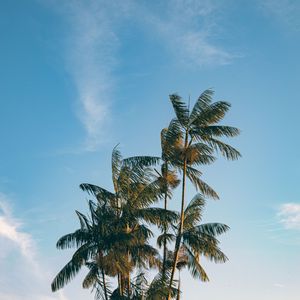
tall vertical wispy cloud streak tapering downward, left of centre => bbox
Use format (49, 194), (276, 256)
(53, 0), (129, 151)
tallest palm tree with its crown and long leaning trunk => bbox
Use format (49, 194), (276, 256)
(168, 90), (240, 299)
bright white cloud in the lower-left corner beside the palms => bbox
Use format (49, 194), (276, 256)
(0, 193), (67, 300)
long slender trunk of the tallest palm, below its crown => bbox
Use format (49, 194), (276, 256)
(168, 130), (189, 300)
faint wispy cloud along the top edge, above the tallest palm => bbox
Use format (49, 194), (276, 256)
(142, 0), (236, 66)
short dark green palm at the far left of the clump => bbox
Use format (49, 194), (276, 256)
(51, 201), (118, 300)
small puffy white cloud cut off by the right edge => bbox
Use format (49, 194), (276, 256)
(278, 203), (300, 229)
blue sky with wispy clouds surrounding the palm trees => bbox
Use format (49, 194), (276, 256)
(0, 0), (300, 300)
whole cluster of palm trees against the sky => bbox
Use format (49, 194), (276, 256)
(51, 90), (240, 300)
